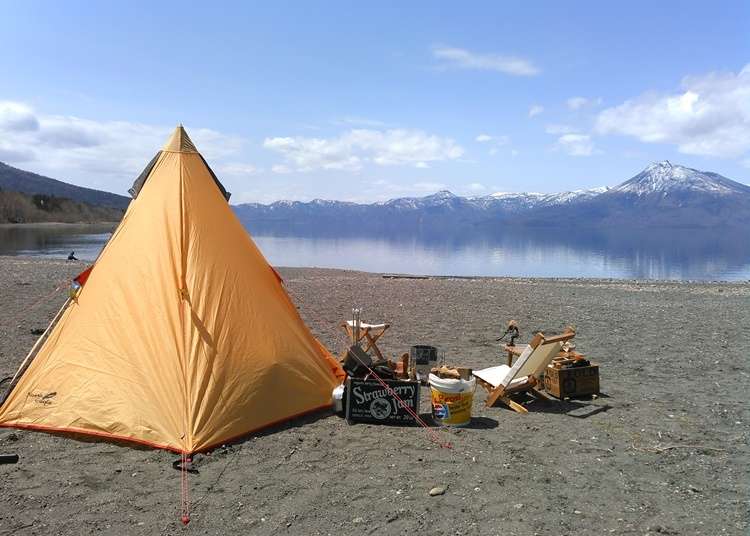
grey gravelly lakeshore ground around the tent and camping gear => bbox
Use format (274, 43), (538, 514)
(0, 257), (750, 535)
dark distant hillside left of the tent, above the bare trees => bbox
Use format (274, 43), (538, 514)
(0, 162), (130, 209)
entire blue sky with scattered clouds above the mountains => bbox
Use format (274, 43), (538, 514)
(0, 1), (750, 202)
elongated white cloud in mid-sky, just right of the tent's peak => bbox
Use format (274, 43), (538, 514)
(263, 129), (464, 171)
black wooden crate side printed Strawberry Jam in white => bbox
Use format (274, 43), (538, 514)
(346, 378), (419, 424)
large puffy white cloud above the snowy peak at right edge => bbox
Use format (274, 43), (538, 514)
(596, 64), (750, 158)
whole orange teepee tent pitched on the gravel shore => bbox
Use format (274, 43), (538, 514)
(0, 126), (343, 453)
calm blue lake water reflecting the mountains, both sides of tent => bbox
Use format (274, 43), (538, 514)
(0, 225), (750, 281)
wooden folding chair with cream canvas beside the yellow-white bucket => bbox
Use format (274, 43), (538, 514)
(474, 328), (575, 413)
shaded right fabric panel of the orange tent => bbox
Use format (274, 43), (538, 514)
(182, 154), (338, 450)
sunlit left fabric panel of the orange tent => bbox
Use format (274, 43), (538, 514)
(0, 153), (188, 450)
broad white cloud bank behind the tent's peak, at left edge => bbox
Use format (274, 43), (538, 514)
(0, 101), (252, 193)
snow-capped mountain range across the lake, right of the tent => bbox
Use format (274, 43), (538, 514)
(235, 161), (750, 232)
